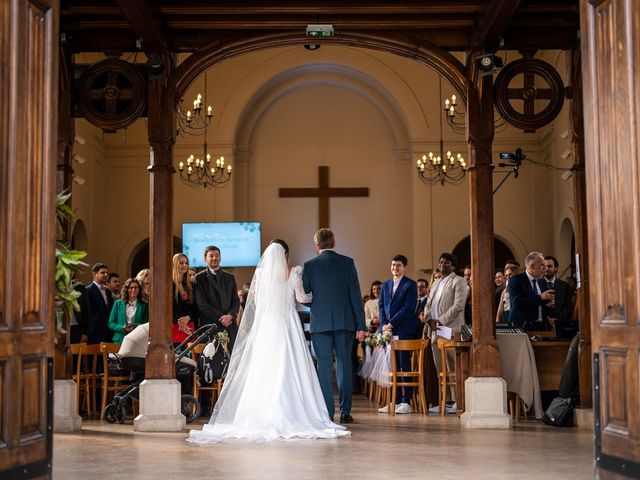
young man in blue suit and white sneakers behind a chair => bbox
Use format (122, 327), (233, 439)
(378, 255), (419, 413)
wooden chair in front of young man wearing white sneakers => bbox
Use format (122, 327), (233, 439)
(389, 340), (429, 415)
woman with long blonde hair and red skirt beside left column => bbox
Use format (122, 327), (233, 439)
(171, 253), (196, 345)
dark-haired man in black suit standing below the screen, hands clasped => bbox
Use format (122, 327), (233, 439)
(193, 245), (240, 348)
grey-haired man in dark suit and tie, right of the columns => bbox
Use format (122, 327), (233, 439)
(508, 252), (555, 331)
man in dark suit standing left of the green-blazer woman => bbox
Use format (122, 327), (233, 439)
(85, 263), (113, 344)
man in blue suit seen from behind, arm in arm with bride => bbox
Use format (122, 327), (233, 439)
(302, 228), (366, 423)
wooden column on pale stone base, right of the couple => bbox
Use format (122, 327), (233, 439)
(466, 64), (500, 377)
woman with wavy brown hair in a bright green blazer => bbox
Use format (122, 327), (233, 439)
(109, 278), (149, 343)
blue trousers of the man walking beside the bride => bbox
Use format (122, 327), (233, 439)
(311, 330), (355, 417)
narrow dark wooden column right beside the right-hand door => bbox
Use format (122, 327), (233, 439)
(571, 45), (593, 408)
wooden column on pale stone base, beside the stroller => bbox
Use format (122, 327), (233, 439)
(145, 54), (176, 379)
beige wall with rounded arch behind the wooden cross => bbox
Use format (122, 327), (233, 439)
(67, 46), (573, 291)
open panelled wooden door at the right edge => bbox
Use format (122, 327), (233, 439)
(581, 0), (640, 478)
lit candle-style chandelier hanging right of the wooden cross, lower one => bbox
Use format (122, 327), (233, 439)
(417, 77), (468, 185)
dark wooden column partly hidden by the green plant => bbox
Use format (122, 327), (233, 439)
(54, 43), (75, 380)
